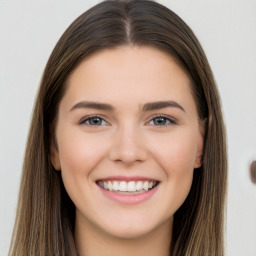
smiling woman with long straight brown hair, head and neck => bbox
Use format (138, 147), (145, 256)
(9, 0), (227, 256)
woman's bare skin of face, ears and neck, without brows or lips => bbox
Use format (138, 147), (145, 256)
(51, 46), (203, 256)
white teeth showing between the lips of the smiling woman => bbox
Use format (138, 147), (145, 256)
(96, 180), (159, 194)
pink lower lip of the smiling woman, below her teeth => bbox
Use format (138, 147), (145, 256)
(98, 184), (159, 204)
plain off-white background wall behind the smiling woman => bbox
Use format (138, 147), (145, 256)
(0, 0), (256, 256)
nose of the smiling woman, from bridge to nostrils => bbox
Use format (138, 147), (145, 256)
(109, 127), (148, 165)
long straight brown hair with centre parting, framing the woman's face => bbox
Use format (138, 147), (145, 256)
(9, 0), (227, 256)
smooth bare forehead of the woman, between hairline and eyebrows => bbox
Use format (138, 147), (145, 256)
(61, 46), (196, 114)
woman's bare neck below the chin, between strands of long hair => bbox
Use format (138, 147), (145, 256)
(75, 216), (172, 256)
